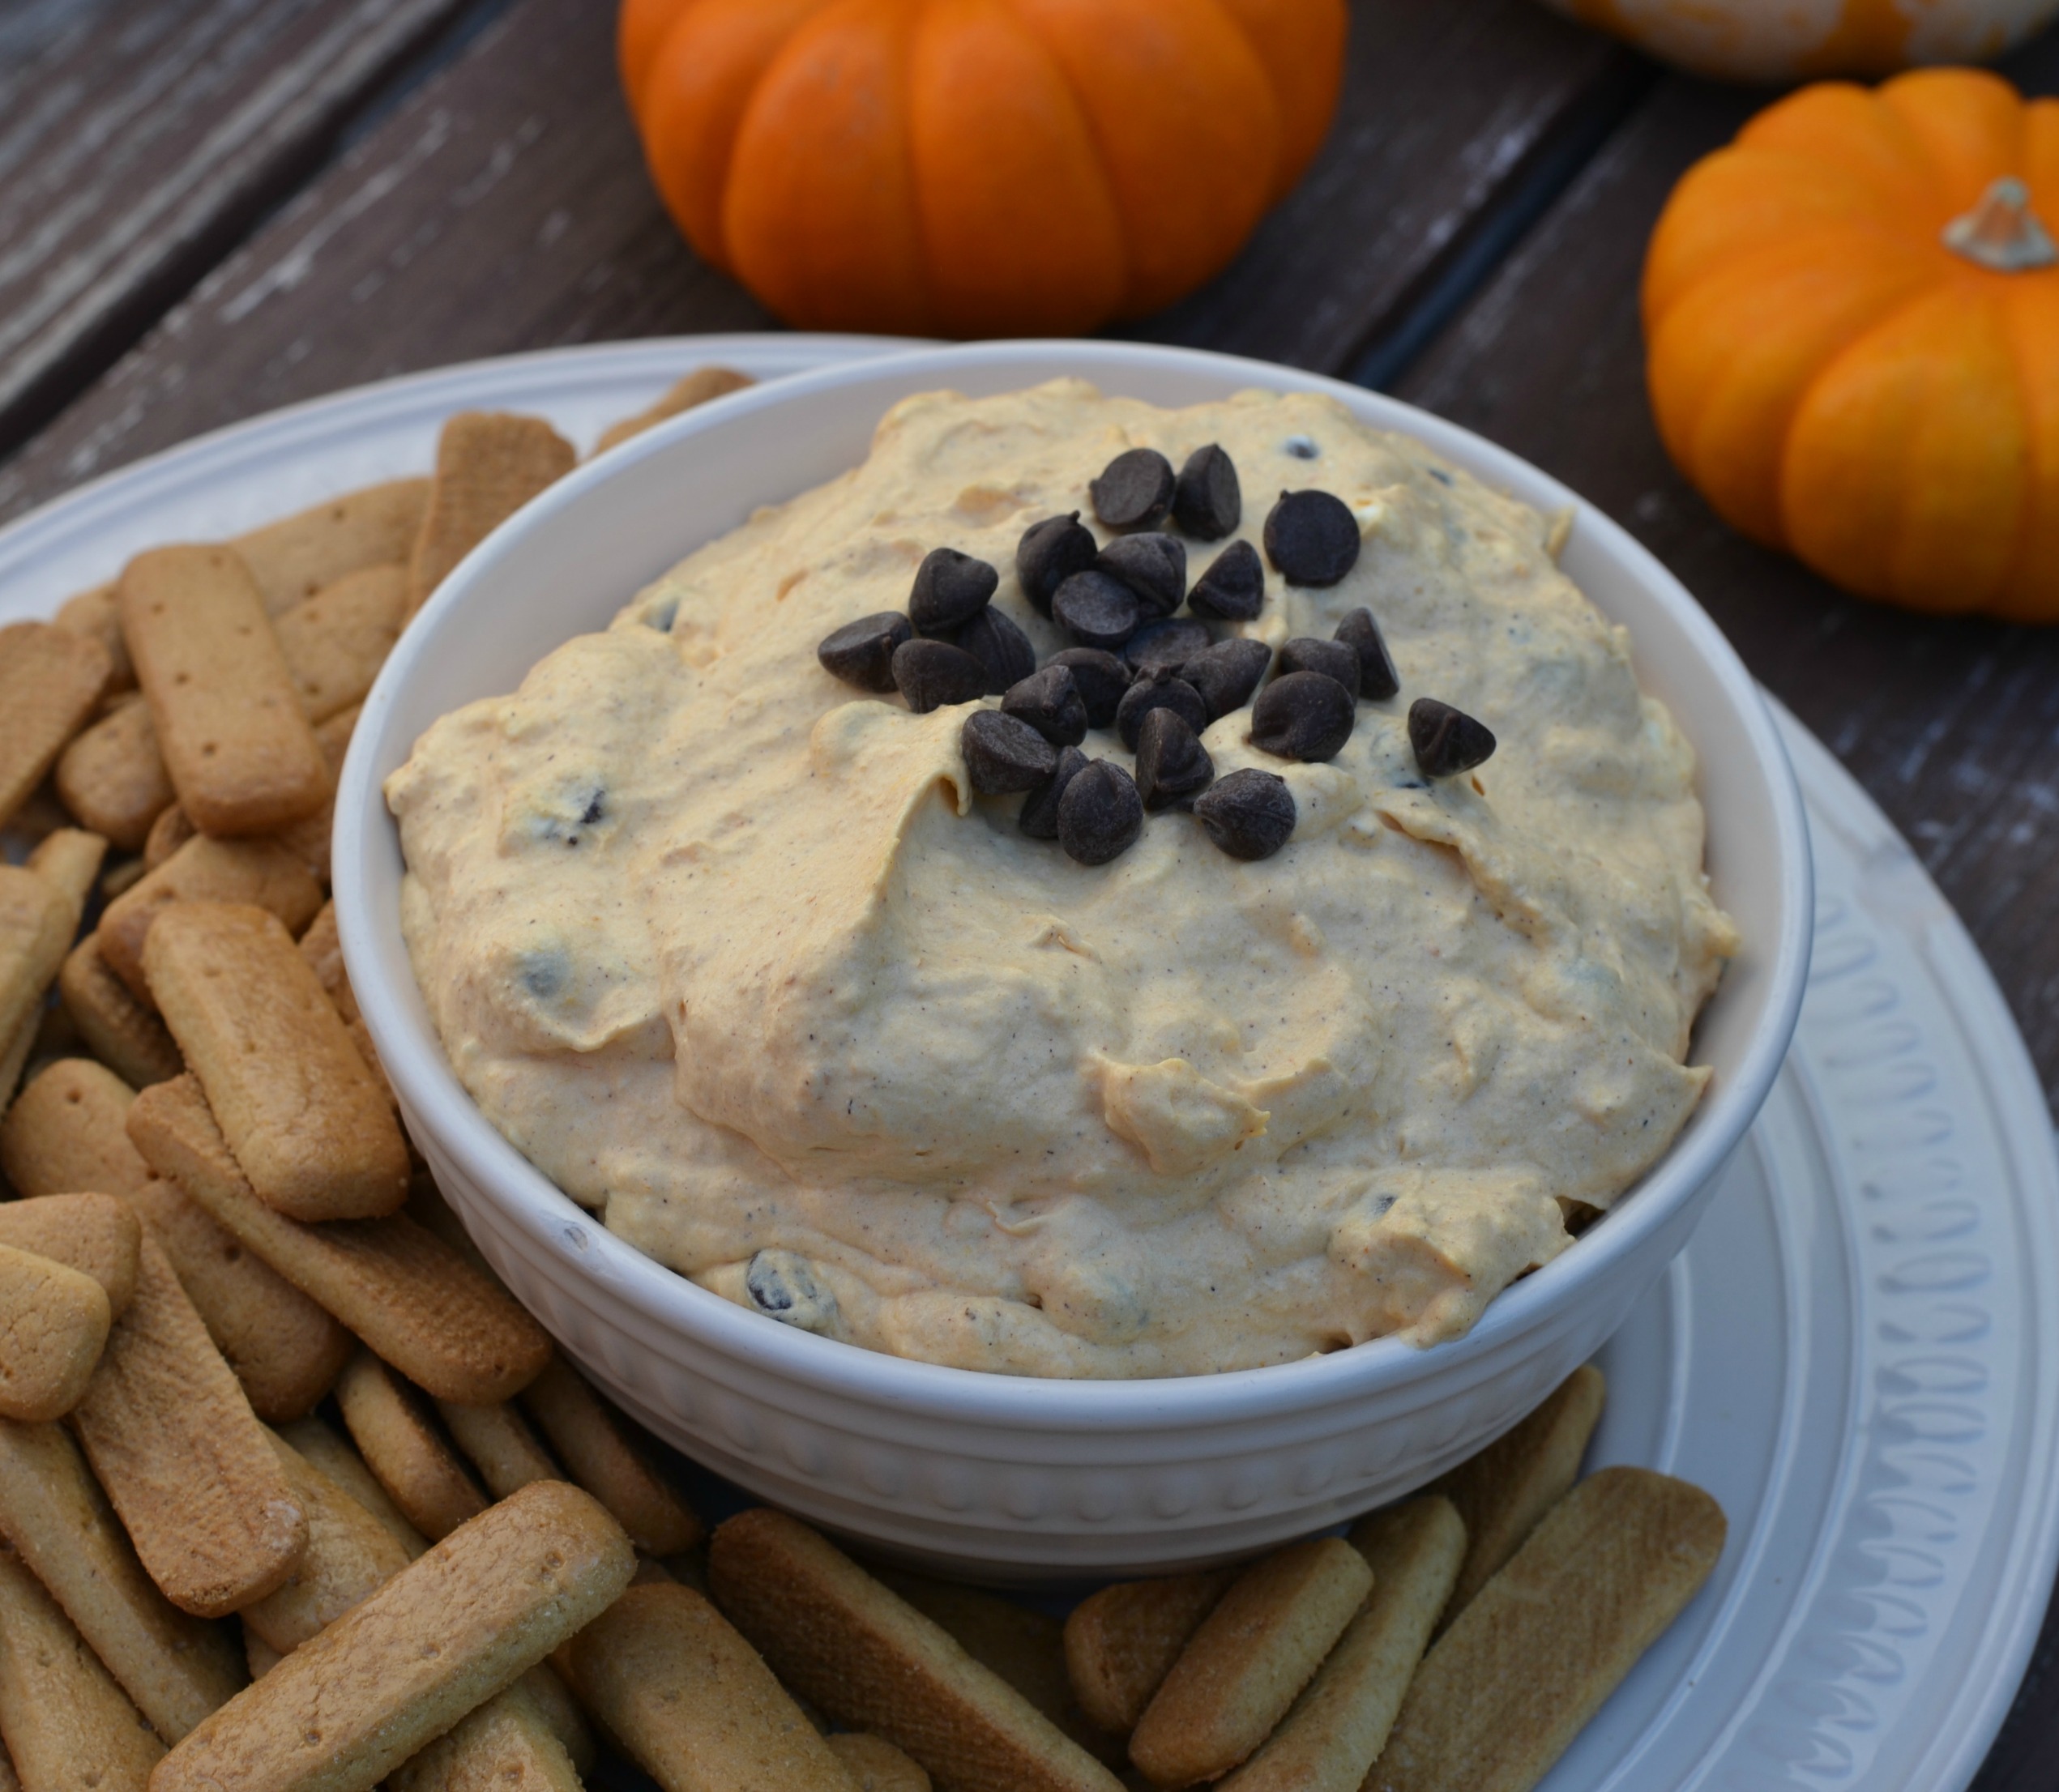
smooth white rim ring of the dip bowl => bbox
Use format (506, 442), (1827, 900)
(334, 339), (1814, 1432)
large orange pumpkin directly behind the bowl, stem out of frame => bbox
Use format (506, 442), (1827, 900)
(620, 0), (1347, 335)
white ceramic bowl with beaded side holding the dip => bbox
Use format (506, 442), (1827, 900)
(335, 342), (1812, 1580)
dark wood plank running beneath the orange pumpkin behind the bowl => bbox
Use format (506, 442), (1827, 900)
(0, 0), (1630, 514)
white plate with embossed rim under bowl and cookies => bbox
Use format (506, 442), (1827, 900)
(0, 335), (2059, 1792)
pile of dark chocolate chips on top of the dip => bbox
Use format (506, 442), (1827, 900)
(818, 442), (1495, 864)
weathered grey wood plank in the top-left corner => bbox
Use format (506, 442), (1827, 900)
(0, 0), (477, 459)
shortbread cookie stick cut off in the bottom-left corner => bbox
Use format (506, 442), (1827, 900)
(0, 1549), (164, 1792)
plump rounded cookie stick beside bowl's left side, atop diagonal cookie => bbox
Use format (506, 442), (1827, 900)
(142, 903), (408, 1220)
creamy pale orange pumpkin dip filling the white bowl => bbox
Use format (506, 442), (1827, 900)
(387, 382), (1736, 1376)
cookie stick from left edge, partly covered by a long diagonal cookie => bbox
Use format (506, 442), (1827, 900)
(0, 1057), (357, 1422)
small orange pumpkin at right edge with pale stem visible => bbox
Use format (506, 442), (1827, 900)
(1643, 68), (2059, 621)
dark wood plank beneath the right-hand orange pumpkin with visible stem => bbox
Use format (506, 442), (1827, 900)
(1396, 49), (2059, 1792)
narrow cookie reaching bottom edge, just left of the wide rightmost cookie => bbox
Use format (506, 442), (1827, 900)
(1221, 1495), (1466, 1792)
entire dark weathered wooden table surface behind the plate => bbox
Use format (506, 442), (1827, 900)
(0, 0), (2059, 1792)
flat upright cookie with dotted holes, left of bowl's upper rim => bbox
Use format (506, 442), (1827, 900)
(122, 545), (330, 835)
